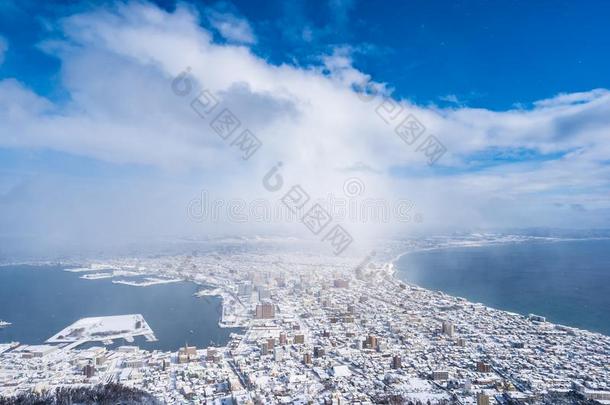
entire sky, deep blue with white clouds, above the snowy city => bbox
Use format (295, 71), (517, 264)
(0, 0), (610, 256)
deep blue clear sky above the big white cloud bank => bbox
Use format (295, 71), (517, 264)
(0, 0), (610, 110)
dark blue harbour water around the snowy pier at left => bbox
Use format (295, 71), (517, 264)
(0, 266), (236, 350)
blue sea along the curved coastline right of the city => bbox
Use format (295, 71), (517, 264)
(396, 240), (610, 335)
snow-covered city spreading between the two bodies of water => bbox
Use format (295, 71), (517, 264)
(0, 235), (610, 405)
